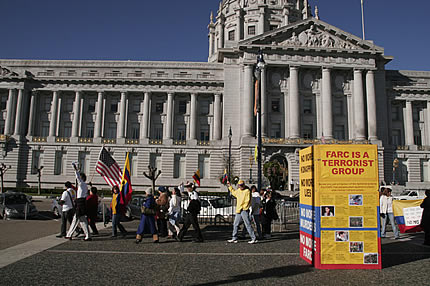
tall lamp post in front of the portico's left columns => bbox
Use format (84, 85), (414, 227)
(254, 49), (265, 190)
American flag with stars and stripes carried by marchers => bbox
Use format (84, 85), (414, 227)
(96, 147), (122, 187)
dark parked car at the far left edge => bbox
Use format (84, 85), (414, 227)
(0, 191), (39, 219)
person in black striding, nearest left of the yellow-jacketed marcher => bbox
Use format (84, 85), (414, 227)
(177, 184), (203, 242)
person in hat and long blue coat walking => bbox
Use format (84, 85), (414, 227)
(136, 188), (158, 243)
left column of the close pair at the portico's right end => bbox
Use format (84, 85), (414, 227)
(354, 70), (366, 140)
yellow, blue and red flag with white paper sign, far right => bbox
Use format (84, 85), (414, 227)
(393, 200), (423, 233)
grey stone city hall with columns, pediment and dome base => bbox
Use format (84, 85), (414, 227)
(0, 0), (430, 191)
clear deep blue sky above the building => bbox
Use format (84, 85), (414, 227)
(0, 0), (430, 70)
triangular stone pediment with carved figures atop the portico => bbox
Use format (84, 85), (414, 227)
(239, 18), (384, 53)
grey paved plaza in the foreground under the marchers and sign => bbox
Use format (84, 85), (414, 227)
(0, 201), (430, 285)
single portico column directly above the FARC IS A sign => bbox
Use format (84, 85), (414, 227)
(321, 68), (333, 139)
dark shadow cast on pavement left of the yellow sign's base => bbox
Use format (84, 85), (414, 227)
(193, 265), (313, 286)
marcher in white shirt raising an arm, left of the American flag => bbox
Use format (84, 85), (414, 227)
(65, 163), (91, 241)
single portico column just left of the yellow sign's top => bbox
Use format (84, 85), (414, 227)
(289, 66), (301, 139)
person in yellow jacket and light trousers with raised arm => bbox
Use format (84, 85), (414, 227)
(227, 180), (257, 244)
